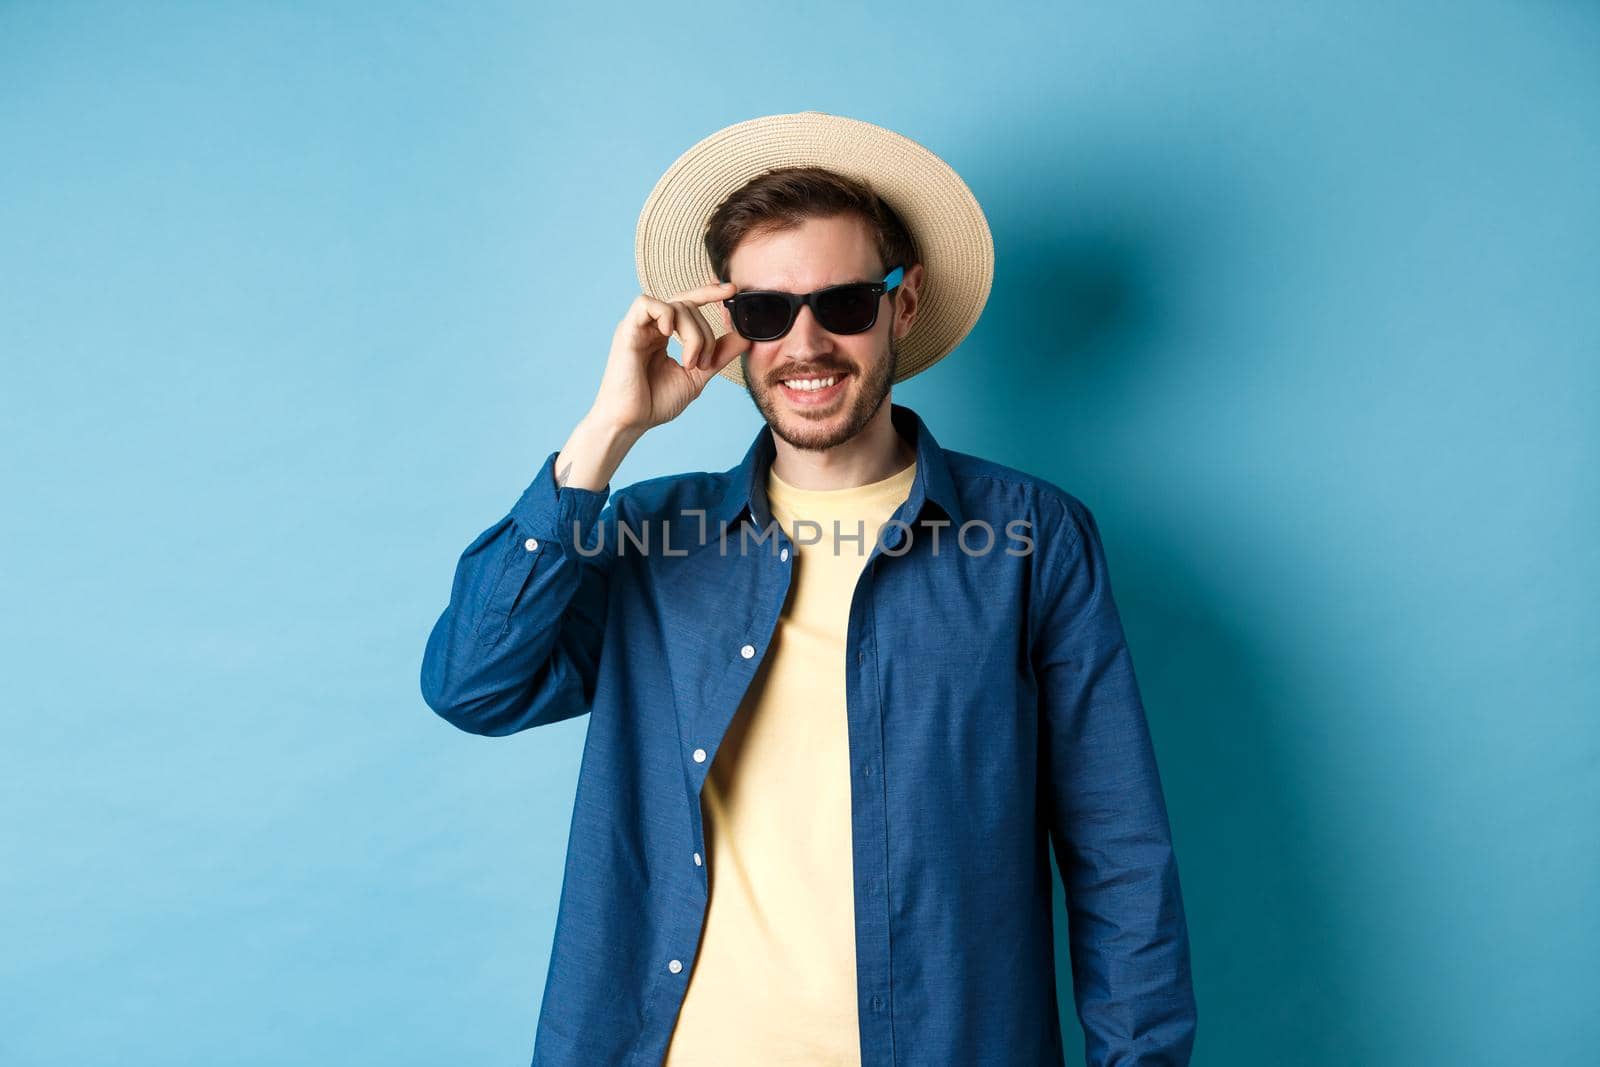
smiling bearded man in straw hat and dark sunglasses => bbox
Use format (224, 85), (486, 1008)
(422, 112), (1195, 1067)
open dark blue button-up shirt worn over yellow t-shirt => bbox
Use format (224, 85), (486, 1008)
(421, 403), (1195, 1067)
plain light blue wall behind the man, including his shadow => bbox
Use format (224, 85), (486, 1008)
(0, 2), (1600, 1067)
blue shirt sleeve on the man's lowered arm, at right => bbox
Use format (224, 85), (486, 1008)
(1032, 496), (1197, 1067)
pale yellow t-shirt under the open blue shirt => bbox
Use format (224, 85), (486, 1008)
(664, 462), (917, 1067)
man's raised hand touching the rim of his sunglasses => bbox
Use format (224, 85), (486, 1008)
(590, 282), (750, 437)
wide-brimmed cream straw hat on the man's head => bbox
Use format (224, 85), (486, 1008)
(634, 110), (995, 386)
